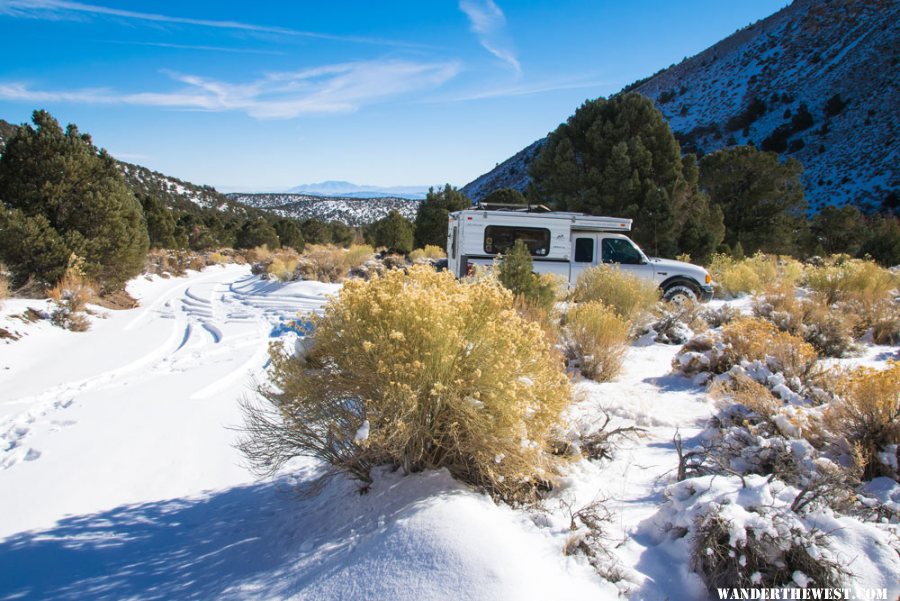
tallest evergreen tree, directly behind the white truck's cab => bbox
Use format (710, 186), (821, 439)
(530, 93), (719, 256)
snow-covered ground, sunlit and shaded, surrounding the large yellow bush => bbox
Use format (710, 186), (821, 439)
(0, 266), (896, 601)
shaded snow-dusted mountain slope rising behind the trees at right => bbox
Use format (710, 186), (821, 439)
(463, 0), (900, 208)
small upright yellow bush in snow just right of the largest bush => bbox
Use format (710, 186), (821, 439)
(564, 302), (631, 382)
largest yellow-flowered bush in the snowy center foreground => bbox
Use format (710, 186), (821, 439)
(242, 266), (570, 501)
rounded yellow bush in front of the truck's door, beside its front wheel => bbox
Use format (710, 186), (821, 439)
(572, 265), (660, 323)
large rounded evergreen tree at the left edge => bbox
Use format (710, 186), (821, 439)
(0, 111), (149, 289)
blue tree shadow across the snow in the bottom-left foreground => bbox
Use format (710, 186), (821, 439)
(0, 468), (464, 600)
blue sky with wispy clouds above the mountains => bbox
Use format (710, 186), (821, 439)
(0, 0), (787, 191)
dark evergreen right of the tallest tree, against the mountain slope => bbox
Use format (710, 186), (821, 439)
(700, 146), (806, 254)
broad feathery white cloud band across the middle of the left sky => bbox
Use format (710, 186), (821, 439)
(0, 60), (460, 119)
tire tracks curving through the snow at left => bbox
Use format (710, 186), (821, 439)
(0, 269), (335, 469)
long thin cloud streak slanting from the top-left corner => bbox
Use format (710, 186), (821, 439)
(0, 0), (421, 47)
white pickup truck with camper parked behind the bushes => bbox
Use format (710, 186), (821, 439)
(447, 205), (713, 301)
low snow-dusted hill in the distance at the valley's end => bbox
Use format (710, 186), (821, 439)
(228, 193), (420, 226)
